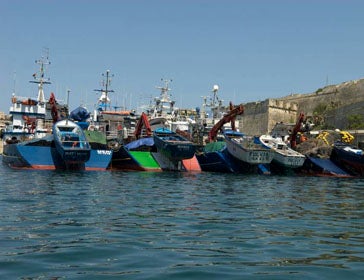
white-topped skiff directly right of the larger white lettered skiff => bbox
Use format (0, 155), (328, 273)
(259, 134), (306, 172)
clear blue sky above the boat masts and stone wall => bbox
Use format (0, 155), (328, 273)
(0, 0), (364, 113)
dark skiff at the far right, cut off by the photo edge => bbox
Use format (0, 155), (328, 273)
(330, 141), (364, 176)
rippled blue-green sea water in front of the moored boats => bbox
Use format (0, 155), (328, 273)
(0, 156), (364, 280)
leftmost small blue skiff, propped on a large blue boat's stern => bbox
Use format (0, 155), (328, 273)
(52, 119), (91, 170)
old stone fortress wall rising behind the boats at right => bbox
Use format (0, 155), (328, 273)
(239, 79), (364, 135)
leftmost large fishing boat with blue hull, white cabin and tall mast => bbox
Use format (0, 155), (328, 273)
(2, 53), (62, 169)
